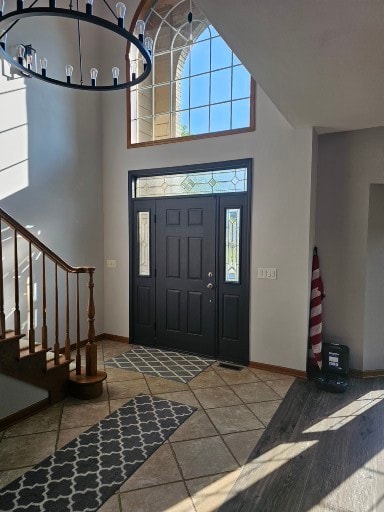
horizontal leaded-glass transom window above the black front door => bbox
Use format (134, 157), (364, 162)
(135, 168), (247, 197)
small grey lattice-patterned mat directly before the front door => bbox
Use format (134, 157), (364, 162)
(105, 346), (215, 383)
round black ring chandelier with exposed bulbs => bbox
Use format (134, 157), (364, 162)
(0, 0), (153, 91)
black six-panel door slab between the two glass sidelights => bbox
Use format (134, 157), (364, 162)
(156, 197), (216, 356)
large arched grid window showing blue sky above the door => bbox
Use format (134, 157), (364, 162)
(128, 0), (254, 145)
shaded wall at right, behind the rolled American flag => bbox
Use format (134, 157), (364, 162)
(316, 128), (384, 370)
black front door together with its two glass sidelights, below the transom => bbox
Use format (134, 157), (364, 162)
(130, 182), (249, 364)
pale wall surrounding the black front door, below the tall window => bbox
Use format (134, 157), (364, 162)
(102, 84), (313, 370)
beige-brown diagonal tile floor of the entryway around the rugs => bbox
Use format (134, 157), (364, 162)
(0, 340), (294, 512)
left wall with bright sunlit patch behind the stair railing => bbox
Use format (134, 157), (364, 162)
(0, 20), (104, 345)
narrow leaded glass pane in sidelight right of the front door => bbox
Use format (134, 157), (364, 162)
(225, 208), (240, 283)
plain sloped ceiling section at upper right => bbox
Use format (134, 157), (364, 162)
(195, 0), (384, 132)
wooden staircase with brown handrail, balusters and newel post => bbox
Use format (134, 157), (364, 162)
(0, 208), (106, 424)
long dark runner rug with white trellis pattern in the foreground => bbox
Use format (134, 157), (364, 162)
(0, 395), (196, 512)
